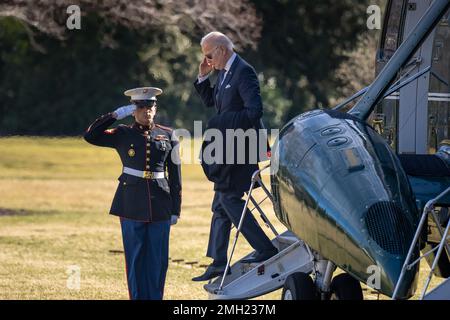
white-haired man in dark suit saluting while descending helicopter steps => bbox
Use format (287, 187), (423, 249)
(192, 32), (277, 281)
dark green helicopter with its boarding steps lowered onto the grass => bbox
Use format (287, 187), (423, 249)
(204, 0), (450, 300)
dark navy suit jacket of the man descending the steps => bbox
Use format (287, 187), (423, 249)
(194, 55), (265, 192)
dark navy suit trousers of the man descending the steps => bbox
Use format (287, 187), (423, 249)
(206, 191), (273, 266)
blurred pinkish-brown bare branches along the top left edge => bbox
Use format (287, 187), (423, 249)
(0, 0), (262, 49)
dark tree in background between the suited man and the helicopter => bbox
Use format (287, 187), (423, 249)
(246, 0), (368, 122)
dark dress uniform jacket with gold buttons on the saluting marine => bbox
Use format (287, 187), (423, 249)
(84, 113), (181, 222)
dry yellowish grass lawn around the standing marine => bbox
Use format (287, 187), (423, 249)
(0, 137), (442, 299)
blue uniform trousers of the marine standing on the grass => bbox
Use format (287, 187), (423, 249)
(120, 218), (170, 300)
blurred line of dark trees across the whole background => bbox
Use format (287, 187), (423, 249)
(0, 0), (383, 134)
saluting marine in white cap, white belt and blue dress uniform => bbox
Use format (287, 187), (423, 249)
(84, 87), (181, 300)
